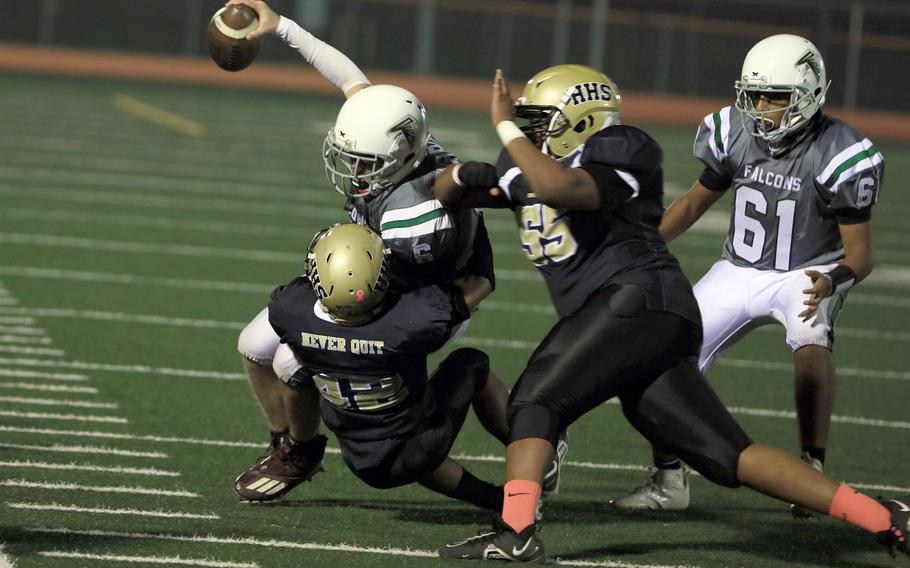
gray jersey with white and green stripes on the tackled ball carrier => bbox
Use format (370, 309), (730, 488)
(351, 138), (479, 287)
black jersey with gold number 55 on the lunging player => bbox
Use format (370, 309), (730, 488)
(496, 125), (701, 322)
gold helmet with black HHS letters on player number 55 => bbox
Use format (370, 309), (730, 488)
(515, 65), (622, 158)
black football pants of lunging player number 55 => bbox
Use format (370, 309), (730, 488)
(509, 285), (752, 487)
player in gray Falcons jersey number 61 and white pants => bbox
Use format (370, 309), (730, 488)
(613, 34), (885, 518)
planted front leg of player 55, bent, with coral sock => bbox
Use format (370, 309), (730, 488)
(439, 285), (701, 561)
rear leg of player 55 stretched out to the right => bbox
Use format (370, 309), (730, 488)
(621, 360), (907, 552)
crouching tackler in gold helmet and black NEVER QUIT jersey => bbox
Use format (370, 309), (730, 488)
(236, 224), (508, 511)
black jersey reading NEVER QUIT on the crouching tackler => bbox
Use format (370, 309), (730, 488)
(269, 277), (465, 441)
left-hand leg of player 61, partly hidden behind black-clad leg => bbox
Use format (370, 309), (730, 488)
(611, 260), (756, 510)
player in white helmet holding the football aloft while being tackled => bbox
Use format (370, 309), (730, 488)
(228, 0), (567, 501)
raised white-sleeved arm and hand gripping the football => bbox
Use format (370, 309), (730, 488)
(227, 0), (370, 98)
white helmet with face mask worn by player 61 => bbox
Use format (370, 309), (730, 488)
(734, 34), (830, 149)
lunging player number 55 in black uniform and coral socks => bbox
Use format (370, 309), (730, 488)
(436, 65), (910, 562)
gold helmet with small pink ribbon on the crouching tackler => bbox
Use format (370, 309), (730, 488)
(307, 224), (389, 325)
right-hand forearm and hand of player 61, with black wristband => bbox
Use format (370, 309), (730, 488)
(799, 221), (875, 319)
